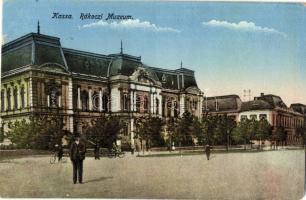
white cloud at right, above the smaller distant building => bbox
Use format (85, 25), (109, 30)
(202, 19), (286, 37)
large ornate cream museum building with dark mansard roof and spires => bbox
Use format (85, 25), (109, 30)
(1, 29), (203, 146)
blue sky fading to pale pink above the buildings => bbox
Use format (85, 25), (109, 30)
(2, 0), (306, 106)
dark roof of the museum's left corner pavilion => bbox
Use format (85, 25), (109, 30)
(2, 33), (67, 72)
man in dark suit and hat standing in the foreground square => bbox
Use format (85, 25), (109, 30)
(70, 136), (86, 184)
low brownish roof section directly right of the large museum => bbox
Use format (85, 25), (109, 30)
(203, 94), (241, 112)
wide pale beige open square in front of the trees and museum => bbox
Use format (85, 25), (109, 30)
(0, 150), (304, 200)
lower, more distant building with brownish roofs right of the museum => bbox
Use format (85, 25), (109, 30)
(203, 93), (306, 145)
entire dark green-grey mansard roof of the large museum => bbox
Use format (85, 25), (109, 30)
(2, 33), (198, 91)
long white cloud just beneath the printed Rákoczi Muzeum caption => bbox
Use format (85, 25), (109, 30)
(80, 19), (180, 33)
